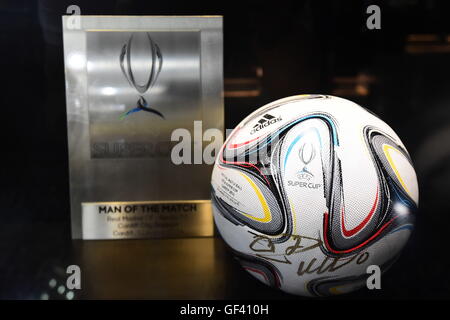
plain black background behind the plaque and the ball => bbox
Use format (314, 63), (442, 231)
(0, 0), (450, 299)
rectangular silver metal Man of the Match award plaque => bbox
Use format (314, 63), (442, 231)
(63, 16), (223, 239)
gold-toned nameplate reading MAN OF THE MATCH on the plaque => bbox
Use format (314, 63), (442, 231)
(81, 200), (214, 240)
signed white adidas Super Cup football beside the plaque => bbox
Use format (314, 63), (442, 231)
(212, 95), (418, 296)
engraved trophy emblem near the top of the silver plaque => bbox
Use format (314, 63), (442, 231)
(120, 32), (164, 119)
